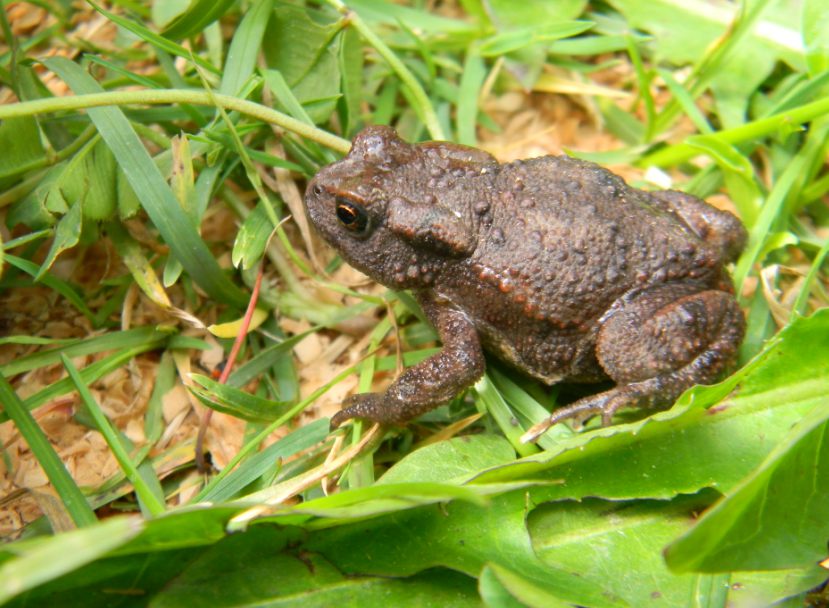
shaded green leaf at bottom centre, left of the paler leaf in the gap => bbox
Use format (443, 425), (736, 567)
(306, 490), (627, 606)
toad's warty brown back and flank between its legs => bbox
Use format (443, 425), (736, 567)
(438, 156), (719, 382)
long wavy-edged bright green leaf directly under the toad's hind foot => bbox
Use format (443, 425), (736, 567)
(478, 309), (829, 499)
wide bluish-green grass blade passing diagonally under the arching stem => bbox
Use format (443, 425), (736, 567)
(45, 58), (247, 306)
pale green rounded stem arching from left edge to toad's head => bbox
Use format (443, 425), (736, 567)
(0, 89), (351, 154)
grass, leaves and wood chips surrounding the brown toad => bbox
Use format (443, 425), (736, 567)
(0, 0), (829, 606)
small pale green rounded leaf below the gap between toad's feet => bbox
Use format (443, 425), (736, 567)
(377, 435), (515, 484)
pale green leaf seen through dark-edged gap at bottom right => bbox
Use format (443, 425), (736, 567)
(527, 495), (823, 607)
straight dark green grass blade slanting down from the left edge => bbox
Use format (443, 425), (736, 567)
(0, 374), (98, 528)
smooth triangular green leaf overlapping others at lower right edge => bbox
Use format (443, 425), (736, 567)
(666, 400), (829, 572)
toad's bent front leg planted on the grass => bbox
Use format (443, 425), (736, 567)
(331, 292), (485, 429)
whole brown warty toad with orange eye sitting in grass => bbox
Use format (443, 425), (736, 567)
(305, 126), (746, 436)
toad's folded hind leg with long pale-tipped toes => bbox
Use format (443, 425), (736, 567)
(522, 283), (745, 441)
